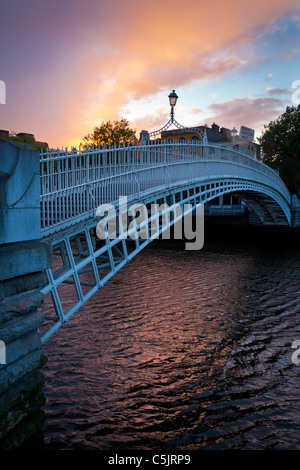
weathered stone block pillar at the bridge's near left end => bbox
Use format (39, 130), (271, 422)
(0, 141), (52, 449)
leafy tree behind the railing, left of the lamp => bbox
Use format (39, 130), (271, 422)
(81, 118), (136, 147)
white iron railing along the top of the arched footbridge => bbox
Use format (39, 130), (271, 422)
(40, 141), (290, 237)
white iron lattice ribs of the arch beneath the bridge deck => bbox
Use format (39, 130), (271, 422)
(41, 173), (290, 342)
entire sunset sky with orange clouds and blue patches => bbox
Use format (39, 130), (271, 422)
(0, 0), (300, 147)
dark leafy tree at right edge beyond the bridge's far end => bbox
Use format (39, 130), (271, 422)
(258, 105), (300, 194)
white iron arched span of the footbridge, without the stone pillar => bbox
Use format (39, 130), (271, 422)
(40, 136), (291, 342)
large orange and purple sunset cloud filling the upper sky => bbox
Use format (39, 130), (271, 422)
(0, 0), (299, 145)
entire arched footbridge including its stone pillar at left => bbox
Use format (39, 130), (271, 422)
(0, 131), (300, 448)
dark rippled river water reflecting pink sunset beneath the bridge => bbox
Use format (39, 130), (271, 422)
(39, 226), (300, 451)
